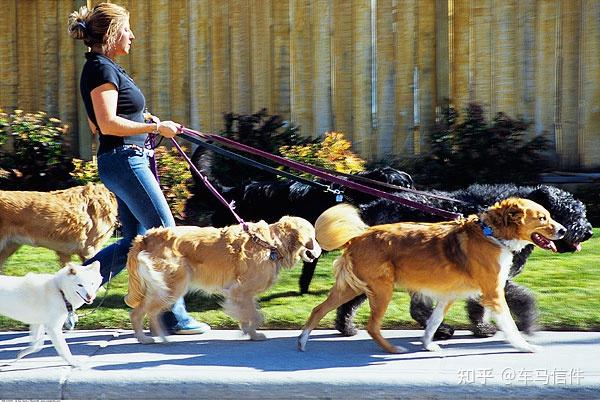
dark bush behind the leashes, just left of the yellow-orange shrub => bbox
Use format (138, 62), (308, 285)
(204, 109), (309, 186)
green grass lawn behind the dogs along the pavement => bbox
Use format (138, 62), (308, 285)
(0, 229), (600, 331)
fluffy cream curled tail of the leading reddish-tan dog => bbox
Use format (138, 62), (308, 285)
(315, 204), (369, 251)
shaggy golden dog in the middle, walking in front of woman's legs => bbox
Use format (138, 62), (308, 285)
(125, 216), (321, 343)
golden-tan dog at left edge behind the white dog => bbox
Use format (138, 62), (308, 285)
(0, 183), (117, 270)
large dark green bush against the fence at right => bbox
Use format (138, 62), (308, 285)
(412, 103), (550, 189)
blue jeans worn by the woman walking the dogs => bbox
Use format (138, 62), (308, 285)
(84, 145), (192, 330)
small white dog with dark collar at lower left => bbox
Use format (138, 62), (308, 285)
(0, 261), (102, 366)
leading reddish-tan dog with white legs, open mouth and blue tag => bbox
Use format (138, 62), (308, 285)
(298, 198), (566, 353)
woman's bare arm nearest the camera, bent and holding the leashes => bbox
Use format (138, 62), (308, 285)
(90, 83), (178, 138)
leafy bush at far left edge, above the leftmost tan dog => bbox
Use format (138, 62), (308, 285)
(0, 110), (71, 190)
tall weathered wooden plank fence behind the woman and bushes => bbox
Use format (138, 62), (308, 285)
(0, 0), (600, 168)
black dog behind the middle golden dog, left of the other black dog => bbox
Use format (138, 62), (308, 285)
(186, 154), (413, 294)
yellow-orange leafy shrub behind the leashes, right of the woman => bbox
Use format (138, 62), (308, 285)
(279, 131), (365, 173)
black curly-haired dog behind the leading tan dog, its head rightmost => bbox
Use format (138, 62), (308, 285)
(336, 184), (592, 339)
